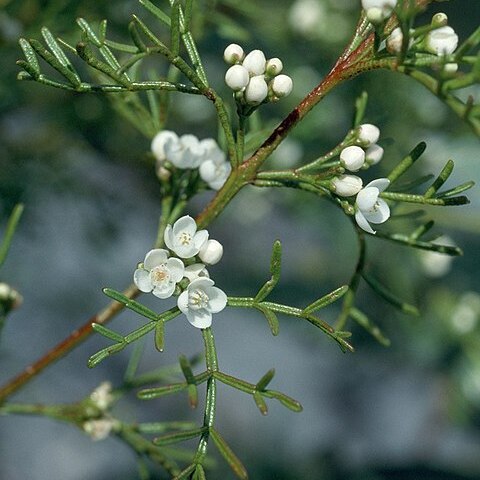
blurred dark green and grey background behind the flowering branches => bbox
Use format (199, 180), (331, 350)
(0, 0), (480, 480)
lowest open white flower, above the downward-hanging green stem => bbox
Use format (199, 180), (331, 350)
(177, 278), (227, 328)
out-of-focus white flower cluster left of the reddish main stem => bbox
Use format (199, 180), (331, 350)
(151, 130), (231, 190)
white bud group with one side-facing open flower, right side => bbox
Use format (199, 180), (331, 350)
(331, 123), (390, 234)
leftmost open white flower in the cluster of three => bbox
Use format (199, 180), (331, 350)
(133, 249), (185, 298)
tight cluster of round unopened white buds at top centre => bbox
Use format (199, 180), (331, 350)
(223, 43), (293, 106)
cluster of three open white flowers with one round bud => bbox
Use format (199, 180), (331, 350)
(133, 215), (227, 328)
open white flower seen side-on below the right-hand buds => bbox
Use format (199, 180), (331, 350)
(355, 178), (390, 234)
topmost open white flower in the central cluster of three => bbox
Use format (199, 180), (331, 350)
(164, 215), (208, 258)
